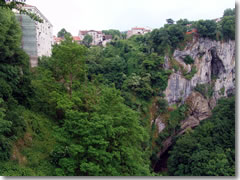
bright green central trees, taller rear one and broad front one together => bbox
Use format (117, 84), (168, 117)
(33, 40), (150, 175)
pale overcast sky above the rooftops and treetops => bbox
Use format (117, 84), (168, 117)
(26, 0), (235, 35)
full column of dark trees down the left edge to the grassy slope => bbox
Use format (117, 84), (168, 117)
(0, 9), (32, 161)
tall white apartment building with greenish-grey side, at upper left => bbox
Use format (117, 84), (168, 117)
(16, 5), (53, 67)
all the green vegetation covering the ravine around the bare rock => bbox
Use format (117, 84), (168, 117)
(0, 6), (235, 176)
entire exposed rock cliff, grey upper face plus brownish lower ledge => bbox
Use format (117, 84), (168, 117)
(155, 38), (235, 157)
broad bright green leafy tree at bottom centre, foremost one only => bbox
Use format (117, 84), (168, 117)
(52, 84), (149, 176)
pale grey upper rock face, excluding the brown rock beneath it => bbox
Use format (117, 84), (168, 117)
(164, 38), (235, 104)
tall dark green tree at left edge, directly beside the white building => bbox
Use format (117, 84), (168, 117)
(0, 8), (31, 104)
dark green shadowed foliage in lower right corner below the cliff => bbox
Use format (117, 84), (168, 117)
(168, 97), (235, 176)
